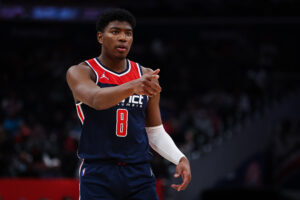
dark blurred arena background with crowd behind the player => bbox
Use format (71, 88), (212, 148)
(0, 0), (300, 200)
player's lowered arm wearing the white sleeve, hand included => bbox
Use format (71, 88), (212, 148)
(142, 68), (192, 191)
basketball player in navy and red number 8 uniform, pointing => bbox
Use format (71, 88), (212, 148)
(66, 9), (191, 200)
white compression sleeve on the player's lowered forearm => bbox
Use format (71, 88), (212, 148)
(146, 125), (184, 165)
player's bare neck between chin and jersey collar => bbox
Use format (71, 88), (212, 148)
(98, 54), (127, 73)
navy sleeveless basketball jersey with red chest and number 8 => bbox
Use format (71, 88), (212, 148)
(76, 58), (152, 163)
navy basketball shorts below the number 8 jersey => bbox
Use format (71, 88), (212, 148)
(80, 161), (158, 200)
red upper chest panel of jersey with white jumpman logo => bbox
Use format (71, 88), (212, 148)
(86, 58), (140, 85)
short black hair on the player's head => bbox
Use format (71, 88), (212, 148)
(96, 8), (136, 32)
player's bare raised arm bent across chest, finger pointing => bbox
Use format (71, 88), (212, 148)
(66, 63), (161, 110)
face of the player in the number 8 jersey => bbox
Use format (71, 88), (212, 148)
(98, 21), (133, 59)
